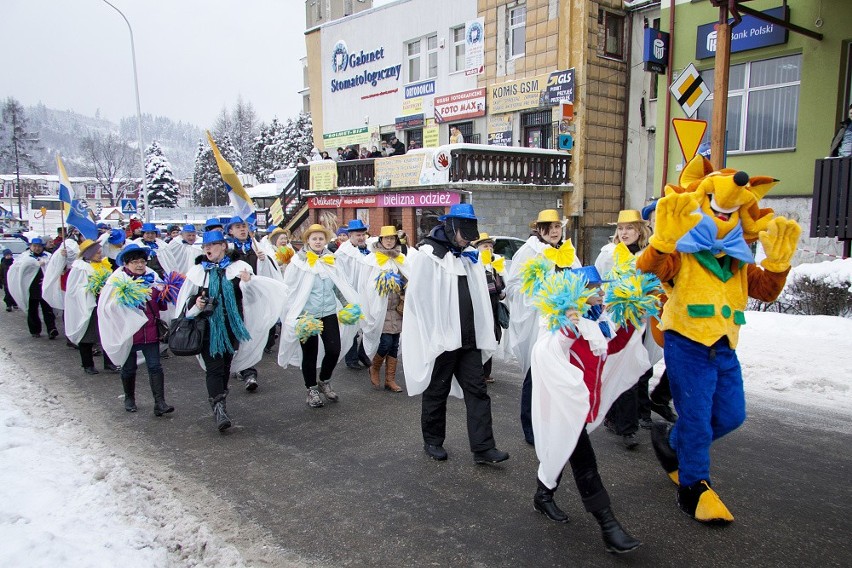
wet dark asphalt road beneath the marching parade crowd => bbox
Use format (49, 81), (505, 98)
(0, 313), (852, 567)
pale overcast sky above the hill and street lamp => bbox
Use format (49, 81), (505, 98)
(0, 0), (312, 127)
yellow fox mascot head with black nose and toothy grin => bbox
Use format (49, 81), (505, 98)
(666, 155), (778, 242)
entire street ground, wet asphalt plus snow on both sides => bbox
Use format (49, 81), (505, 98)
(0, 312), (852, 568)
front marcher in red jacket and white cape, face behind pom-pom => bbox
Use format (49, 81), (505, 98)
(531, 266), (650, 554)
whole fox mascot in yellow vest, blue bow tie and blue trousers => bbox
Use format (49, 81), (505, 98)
(637, 156), (801, 523)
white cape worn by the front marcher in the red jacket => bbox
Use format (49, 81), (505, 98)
(532, 320), (650, 489)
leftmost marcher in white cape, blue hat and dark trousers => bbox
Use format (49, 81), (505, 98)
(6, 237), (59, 339)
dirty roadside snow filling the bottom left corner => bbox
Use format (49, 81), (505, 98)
(0, 350), (250, 568)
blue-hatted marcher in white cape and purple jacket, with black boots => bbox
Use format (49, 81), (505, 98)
(98, 243), (174, 416)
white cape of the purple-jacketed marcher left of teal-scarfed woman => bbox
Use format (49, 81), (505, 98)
(98, 268), (154, 365)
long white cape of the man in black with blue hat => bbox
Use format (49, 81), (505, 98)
(400, 245), (497, 398)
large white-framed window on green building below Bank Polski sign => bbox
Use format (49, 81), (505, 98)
(697, 54), (802, 153)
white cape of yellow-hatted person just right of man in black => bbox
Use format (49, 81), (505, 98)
(506, 235), (582, 375)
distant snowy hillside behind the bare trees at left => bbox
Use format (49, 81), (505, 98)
(26, 104), (203, 179)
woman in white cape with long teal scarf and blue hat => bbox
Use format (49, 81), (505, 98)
(176, 231), (287, 432)
